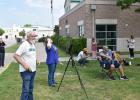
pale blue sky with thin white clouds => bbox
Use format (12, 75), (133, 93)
(0, 0), (65, 27)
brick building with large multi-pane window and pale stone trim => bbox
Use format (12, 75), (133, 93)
(59, 0), (140, 51)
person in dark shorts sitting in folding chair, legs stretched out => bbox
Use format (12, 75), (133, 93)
(98, 46), (128, 80)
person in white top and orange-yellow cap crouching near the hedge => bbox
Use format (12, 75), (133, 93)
(77, 48), (88, 65)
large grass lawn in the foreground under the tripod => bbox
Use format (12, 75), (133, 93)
(0, 59), (140, 100)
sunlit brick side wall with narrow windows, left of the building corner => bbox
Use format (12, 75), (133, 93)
(59, 5), (92, 37)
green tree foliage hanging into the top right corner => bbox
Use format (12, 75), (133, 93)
(117, 0), (140, 12)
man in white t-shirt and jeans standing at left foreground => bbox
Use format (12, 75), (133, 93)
(14, 31), (37, 100)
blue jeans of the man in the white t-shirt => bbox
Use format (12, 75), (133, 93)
(20, 71), (36, 100)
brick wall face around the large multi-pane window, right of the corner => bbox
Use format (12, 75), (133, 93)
(96, 5), (140, 38)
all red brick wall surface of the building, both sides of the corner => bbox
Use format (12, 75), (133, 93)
(59, 5), (140, 38)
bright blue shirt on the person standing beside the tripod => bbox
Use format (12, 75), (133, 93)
(46, 45), (59, 64)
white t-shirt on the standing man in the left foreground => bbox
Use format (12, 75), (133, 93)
(16, 41), (36, 72)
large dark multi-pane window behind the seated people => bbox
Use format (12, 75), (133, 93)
(96, 24), (117, 50)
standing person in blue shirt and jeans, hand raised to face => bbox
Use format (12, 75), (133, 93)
(45, 38), (59, 87)
